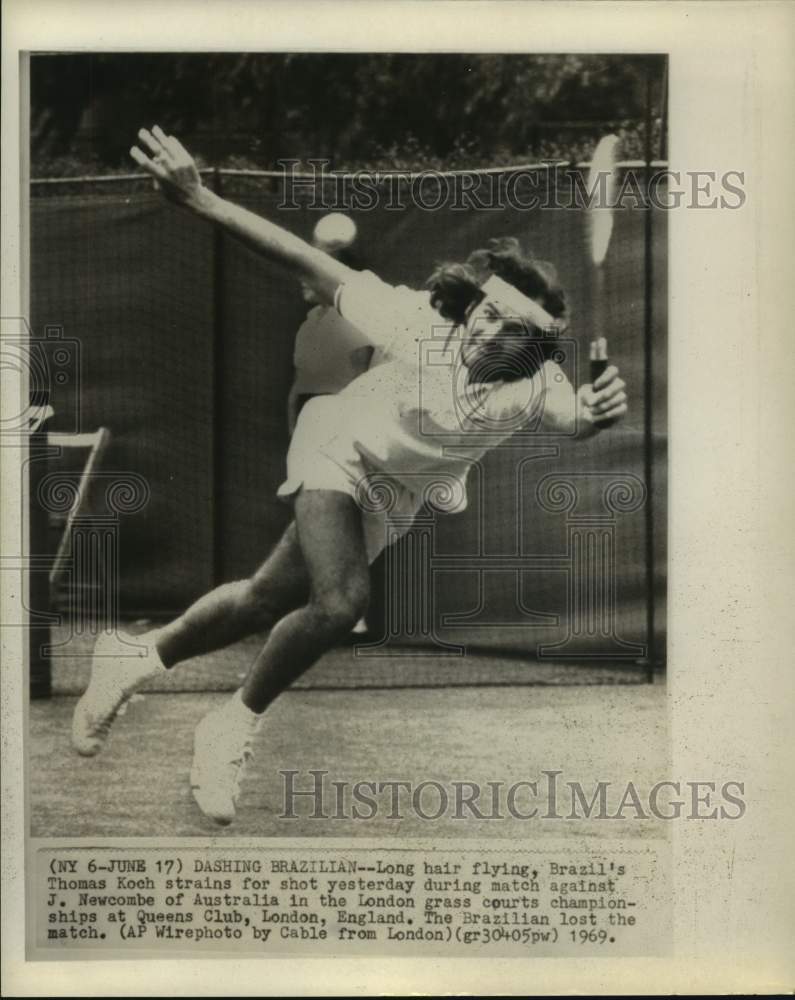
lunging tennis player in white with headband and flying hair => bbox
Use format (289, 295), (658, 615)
(72, 127), (627, 824)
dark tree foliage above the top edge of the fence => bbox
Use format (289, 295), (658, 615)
(31, 53), (664, 176)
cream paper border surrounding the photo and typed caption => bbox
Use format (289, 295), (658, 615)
(0, 0), (795, 996)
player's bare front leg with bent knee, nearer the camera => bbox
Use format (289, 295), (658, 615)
(242, 490), (370, 713)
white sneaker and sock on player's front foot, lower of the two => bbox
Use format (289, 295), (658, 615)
(190, 706), (255, 826)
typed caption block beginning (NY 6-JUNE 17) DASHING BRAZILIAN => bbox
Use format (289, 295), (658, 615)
(31, 842), (669, 958)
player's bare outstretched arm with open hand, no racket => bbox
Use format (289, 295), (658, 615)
(130, 125), (355, 305)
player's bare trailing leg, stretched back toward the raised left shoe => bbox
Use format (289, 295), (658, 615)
(153, 522), (309, 667)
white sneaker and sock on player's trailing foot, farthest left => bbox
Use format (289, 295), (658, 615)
(72, 633), (164, 757)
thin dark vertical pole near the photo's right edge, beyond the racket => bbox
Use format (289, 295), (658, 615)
(643, 59), (657, 683)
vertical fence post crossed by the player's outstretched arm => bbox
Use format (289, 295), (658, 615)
(210, 167), (226, 586)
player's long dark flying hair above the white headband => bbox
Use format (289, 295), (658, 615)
(426, 236), (568, 333)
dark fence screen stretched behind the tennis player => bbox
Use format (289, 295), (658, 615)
(31, 163), (667, 657)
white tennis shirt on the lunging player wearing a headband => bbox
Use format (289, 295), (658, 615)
(299, 271), (576, 510)
